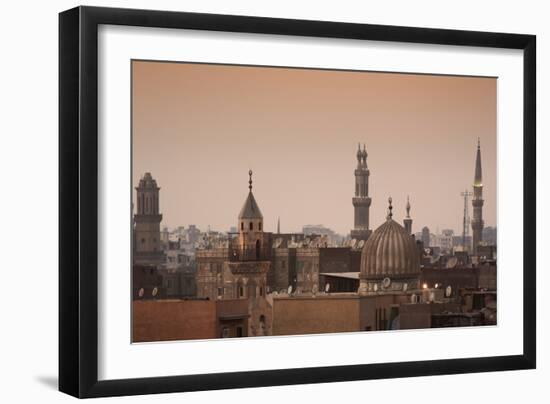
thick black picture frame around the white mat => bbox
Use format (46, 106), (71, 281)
(59, 7), (536, 398)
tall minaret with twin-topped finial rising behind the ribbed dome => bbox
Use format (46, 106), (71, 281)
(351, 144), (371, 240)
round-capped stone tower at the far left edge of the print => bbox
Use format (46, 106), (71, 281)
(134, 173), (164, 265)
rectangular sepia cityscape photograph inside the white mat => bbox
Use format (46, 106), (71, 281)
(129, 60), (497, 342)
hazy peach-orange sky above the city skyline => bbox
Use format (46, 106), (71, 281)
(132, 61), (496, 234)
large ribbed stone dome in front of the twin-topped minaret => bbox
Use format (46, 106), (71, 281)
(361, 218), (420, 279)
